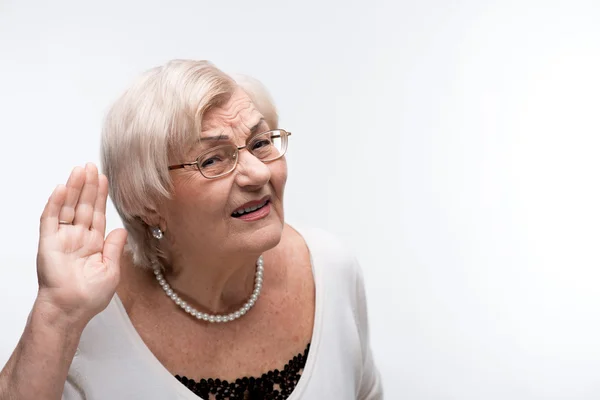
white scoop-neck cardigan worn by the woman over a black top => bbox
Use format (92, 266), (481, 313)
(63, 230), (383, 400)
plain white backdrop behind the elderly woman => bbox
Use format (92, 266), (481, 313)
(0, 0), (600, 400)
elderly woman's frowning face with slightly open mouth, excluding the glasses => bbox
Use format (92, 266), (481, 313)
(161, 89), (287, 259)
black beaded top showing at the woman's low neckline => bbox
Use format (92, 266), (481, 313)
(175, 343), (310, 400)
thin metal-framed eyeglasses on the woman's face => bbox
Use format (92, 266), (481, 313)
(169, 129), (292, 179)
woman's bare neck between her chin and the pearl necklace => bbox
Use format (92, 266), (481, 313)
(164, 254), (260, 314)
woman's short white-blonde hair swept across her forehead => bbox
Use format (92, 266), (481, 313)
(101, 60), (278, 268)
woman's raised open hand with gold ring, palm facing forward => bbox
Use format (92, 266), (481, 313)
(37, 163), (127, 324)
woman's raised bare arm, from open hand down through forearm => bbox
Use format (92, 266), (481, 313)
(0, 164), (127, 400)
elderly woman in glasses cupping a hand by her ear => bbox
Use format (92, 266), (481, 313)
(0, 61), (382, 400)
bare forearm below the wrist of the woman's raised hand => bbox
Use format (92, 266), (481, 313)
(0, 299), (85, 400)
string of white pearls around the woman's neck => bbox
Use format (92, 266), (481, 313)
(154, 256), (264, 322)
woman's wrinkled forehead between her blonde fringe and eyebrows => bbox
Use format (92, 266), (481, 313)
(201, 89), (263, 137)
